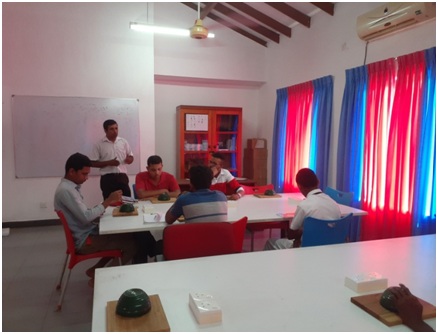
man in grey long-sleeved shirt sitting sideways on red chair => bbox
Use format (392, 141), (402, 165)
(54, 153), (138, 285)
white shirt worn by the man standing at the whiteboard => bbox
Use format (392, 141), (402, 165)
(90, 136), (133, 175)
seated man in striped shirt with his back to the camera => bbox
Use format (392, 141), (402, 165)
(165, 166), (228, 224)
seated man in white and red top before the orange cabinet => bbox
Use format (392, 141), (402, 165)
(209, 152), (244, 200)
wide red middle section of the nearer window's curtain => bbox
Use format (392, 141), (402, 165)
(362, 52), (425, 240)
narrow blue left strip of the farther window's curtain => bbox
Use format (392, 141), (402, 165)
(272, 88), (288, 193)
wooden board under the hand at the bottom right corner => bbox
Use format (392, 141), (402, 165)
(351, 293), (435, 327)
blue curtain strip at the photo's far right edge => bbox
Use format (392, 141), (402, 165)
(412, 48), (436, 235)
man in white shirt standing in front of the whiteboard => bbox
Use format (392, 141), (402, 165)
(90, 119), (134, 199)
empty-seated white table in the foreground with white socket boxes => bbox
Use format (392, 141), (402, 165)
(92, 235), (436, 332)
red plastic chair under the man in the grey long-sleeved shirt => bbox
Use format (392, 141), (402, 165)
(56, 211), (122, 311)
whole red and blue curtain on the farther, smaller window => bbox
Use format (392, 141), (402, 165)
(272, 76), (333, 192)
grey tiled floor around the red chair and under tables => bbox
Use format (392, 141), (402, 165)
(2, 226), (279, 332)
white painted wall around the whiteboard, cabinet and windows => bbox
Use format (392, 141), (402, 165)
(2, 3), (436, 222)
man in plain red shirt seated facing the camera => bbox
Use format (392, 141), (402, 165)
(135, 155), (181, 199)
